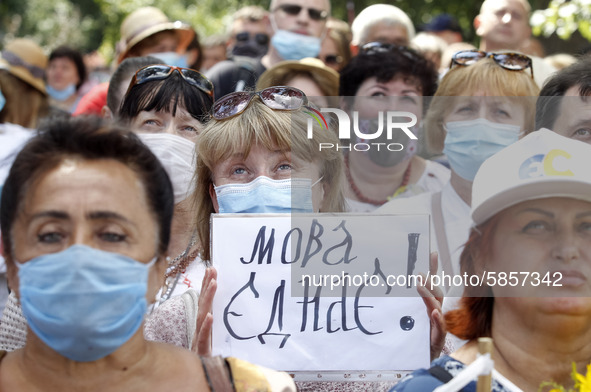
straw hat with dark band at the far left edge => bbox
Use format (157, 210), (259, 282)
(0, 38), (47, 94)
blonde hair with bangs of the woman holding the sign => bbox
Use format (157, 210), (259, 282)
(192, 97), (345, 260)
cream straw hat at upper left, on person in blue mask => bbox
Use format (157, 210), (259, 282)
(117, 7), (195, 63)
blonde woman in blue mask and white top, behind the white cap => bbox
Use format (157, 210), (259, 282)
(378, 55), (539, 282)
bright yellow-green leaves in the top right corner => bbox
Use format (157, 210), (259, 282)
(531, 0), (591, 41)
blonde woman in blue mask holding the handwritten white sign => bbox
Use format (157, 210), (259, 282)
(178, 86), (444, 391)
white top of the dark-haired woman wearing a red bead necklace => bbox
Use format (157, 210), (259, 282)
(346, 161), (450, 212)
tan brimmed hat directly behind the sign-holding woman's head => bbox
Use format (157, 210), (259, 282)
(256, 57), (339, 97)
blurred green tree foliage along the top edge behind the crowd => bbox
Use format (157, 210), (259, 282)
(12, 0), (591, 58)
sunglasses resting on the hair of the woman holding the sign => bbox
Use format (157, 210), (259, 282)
(212, 86), (308, 120)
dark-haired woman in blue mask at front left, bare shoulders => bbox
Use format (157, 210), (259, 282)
(0, 118), (293, 391)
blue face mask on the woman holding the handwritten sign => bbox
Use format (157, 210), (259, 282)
(214, 176), (322, 214)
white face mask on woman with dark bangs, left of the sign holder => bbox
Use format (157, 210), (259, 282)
(138, 133), (196, 204)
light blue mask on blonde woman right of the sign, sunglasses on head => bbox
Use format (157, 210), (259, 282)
(443, 118), (521, 181)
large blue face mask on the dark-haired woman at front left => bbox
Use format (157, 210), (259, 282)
(17, 245), (156, 362)
